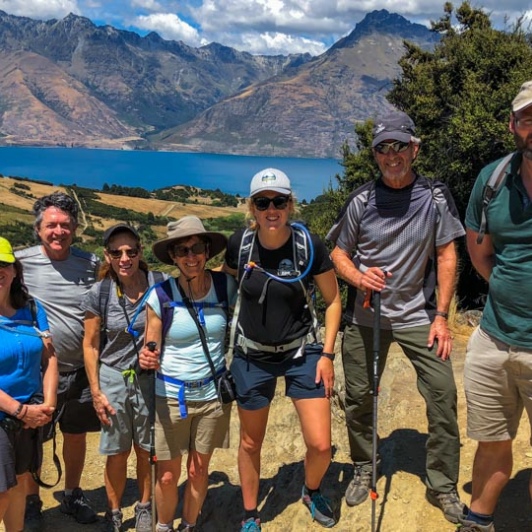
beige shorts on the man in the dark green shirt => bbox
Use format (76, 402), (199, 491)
(464, 327), (532, 442)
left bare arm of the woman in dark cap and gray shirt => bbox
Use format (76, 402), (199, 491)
(83, 312), (115, 425)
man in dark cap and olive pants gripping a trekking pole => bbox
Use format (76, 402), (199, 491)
(327, 112), (464, 523)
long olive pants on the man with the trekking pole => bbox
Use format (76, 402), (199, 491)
(342, 325), (460, 493)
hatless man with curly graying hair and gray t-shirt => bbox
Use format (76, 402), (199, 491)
(16, 192), (100, 530)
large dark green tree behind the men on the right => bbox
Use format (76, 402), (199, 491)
(310, 2), (532, 304)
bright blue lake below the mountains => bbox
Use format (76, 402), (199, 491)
(0, 147), (343, 201)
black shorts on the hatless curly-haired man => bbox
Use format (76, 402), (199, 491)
(44, 368), (101, 439)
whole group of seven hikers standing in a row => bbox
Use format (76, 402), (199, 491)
(0, 81), (532, 532)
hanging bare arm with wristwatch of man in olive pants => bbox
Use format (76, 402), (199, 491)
(427, 241), (458, 360)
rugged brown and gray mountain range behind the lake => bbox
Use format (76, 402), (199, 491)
(0, 10), (438, 157)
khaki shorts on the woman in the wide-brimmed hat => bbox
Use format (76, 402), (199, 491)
(155, 396), (231, 460)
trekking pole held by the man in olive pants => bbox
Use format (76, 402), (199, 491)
(370, 291), (381, 532)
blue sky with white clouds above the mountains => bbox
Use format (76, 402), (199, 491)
(0, 0), (532, 55)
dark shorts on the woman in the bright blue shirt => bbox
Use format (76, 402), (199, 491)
(0, 428), (42, 493)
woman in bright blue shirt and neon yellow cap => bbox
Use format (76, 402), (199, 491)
(0, 237), (58, 530)
